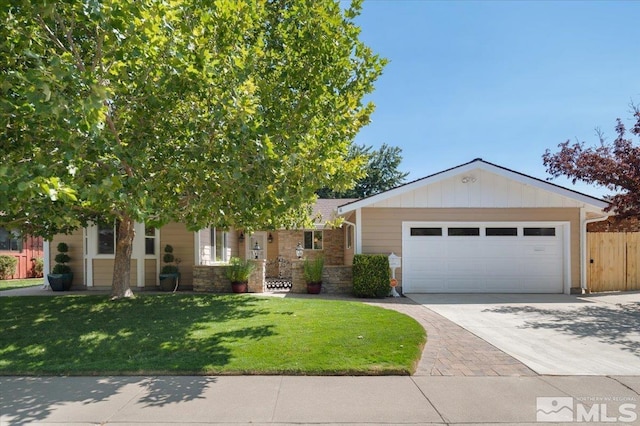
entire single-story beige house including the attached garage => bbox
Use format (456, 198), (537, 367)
(45, 159), (608, 293)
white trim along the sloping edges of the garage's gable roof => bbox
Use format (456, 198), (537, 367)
(338, 158), (608, 214)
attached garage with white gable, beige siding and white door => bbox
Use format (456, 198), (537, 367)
(338, 159), (607, 293)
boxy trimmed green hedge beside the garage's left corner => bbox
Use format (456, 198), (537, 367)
(353, 254), (391, 297)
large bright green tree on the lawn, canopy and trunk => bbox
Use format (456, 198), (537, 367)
(0, 0), (384, 298)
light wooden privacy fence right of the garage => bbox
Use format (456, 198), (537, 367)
(587, 232), (640, 292)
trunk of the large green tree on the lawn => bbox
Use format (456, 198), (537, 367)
(111, 216), (136, 300)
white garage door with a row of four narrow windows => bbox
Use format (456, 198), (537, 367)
(402, 222), (569, 293)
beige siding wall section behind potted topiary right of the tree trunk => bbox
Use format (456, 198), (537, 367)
(158, 223), (195, 287)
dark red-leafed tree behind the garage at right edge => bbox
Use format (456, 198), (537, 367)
(542, 106), (640, 216)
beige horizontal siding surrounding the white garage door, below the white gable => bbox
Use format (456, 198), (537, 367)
(361, 207), (580, 288)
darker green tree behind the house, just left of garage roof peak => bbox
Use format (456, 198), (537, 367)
(318, 143), (409, 198)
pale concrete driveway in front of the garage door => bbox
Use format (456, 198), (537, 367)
(407, 292), (640, 375)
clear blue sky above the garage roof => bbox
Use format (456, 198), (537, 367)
(356, 0), (640, 196)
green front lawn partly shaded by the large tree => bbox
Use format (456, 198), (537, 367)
(0, 294), (426, 375)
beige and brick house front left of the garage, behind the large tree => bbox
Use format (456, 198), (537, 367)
(44, 199), (355, 290)
